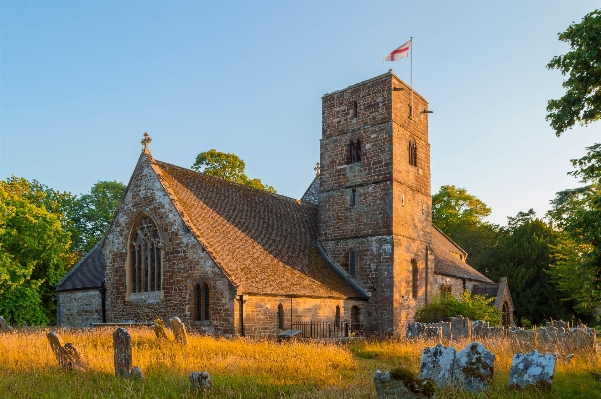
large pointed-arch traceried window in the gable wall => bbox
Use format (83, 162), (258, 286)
(130, 216), (163, 293)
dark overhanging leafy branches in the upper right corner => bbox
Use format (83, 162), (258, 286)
(546, 10), (601, 136)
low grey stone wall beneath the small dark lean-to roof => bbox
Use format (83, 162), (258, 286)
(56, 289), (102, 327)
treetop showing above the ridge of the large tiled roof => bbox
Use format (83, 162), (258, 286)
(192, 149), (276, 193)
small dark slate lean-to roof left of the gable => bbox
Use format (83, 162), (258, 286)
(56, 239), (104, 291)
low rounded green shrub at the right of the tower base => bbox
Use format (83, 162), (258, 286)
(415, 290), (503, 326)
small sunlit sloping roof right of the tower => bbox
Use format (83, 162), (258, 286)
(432, 225), (492, 283)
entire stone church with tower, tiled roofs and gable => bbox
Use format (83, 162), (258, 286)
(56, 71), (513, 337)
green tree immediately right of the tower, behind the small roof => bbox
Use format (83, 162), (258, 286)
(432, 185), (498, 273)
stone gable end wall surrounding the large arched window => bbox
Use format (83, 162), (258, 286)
(104, 154), (235, 334)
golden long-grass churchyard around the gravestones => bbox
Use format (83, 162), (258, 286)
(0, 328), (601, 399)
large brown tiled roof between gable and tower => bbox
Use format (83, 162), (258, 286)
(147, 155), (366, 298)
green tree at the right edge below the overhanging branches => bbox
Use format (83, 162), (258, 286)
(549, 144), (601, 314)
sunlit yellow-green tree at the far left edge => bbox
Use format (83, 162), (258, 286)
(0, 177), (76, 325)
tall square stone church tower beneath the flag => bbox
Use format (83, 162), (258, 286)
(318, 71), (434, 336)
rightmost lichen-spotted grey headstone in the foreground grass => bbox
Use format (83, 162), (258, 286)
(507, 350), (555, 388)
